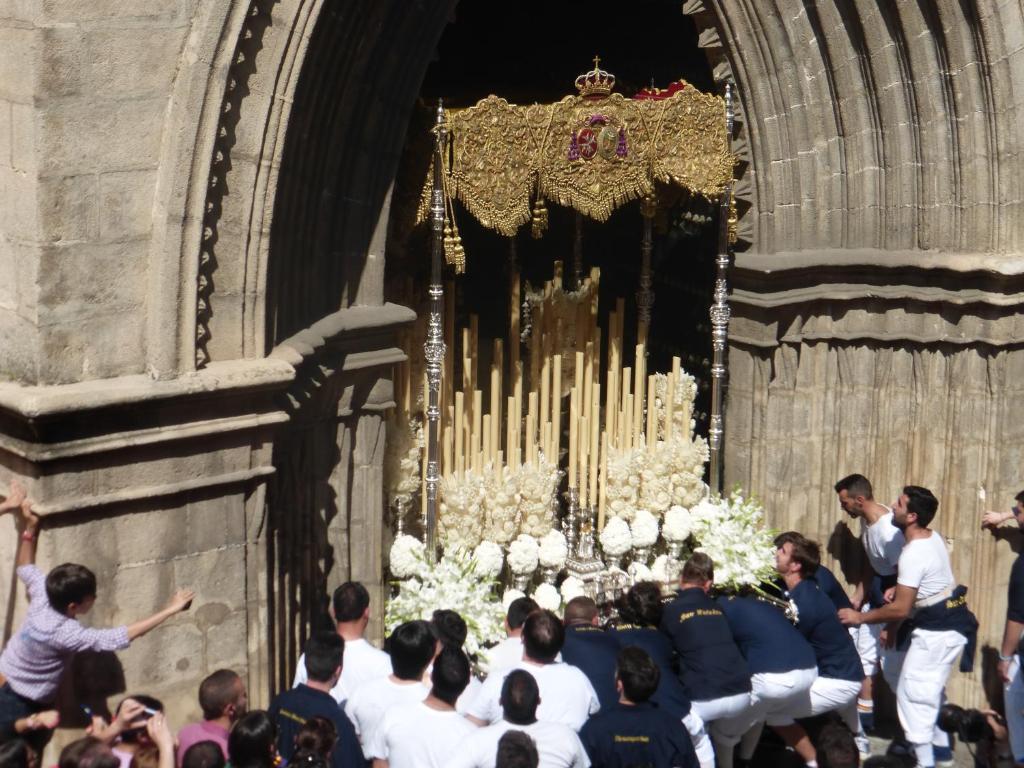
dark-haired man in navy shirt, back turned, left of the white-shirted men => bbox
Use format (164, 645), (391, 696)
(267, 631), (366, 768)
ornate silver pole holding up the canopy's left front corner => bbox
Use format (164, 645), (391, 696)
(423, 100), (447, 562)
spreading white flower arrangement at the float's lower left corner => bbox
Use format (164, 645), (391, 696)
(384, 549), (505, 655)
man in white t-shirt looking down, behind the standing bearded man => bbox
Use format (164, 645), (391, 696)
(835, 474), (904, 754)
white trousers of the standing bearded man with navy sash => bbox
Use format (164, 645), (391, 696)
(886, 629), (967, 746)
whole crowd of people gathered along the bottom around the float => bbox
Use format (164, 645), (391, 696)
(0, 475), (1024, 768)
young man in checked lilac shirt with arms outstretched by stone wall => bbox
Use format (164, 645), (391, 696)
(0, 480), (196, 755)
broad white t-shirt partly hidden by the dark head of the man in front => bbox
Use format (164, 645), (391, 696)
(466, 662), (600, 731)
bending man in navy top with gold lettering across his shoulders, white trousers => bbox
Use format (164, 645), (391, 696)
(662, 552), (752, 751)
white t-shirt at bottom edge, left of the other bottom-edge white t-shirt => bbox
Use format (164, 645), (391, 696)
(364, 701), (479, 768)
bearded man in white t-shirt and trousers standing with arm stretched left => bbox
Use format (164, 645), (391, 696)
(840, 485), (978, 768)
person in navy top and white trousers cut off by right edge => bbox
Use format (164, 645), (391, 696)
(981, 490), (1024, 766)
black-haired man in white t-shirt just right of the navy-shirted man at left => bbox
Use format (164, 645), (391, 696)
(345, 621), (440, 760)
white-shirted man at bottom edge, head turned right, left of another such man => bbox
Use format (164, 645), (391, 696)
(365, 645), (478, 768)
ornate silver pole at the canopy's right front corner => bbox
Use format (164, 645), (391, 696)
(708, 83), (733, 494)
